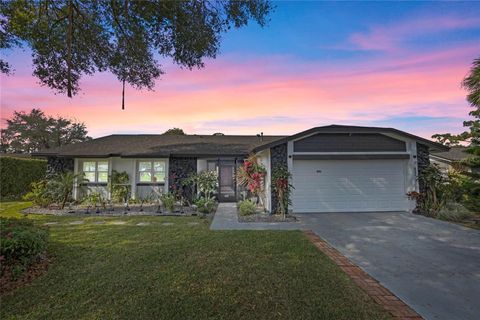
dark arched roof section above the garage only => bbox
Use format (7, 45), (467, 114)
(254, 124), (449, 151)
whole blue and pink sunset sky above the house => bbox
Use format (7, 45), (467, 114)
(1, 2), (480, 138)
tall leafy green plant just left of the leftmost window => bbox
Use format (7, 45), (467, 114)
(47, 171), (87, 209)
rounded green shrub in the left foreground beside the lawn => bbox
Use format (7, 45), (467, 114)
(0, 218), (48, 277)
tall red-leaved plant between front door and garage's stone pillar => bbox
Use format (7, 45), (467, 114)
(237, 155), (267, 205)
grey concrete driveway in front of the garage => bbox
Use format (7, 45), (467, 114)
(298, 213), (480, 320)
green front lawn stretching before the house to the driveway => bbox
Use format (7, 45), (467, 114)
(0, 203), (389, 319)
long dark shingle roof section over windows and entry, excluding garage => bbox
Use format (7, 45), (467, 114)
(36, 134), (284, 158)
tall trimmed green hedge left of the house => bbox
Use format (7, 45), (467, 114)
(0, 157), (47, 200)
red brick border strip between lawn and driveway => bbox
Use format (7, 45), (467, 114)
(304, 231), (423, 320)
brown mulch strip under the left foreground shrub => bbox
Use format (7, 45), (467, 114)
(0, 256), (53, 296)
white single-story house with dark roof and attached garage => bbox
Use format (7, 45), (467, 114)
(35, 125), (448, 213)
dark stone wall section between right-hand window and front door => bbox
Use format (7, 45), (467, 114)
(168, 157), (197, 201)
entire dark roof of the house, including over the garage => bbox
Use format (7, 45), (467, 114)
(34, 125), (448, 158)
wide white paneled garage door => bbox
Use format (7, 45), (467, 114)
(292, 160), (409, 213)
